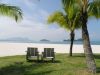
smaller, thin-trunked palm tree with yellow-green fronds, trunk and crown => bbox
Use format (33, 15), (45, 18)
(48, 1), (81, 56)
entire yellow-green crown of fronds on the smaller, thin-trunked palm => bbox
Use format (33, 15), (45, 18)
(48, 0), (81, 31)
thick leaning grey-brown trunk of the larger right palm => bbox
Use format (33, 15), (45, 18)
(82, 12), (96, 73)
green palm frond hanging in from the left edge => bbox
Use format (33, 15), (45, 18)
(0, 4), (22, 21)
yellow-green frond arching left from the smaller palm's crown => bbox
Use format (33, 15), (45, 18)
(47, 11), (70, 30)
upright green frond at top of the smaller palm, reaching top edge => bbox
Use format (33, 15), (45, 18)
(62, 0), (80, 20)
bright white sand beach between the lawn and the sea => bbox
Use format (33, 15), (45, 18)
(0, 43), (100, 57)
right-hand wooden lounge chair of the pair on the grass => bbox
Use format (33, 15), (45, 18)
(42, 48), (55, 62)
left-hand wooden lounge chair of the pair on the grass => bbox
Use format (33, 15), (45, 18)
(26, 47), (39, 61)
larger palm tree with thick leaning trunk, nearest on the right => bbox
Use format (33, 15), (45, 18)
(62, 0), (100, 73)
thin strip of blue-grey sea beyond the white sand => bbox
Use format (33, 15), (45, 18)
(0, 41), (100, 45)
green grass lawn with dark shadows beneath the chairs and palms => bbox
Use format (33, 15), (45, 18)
(0, 54), (100, 75)
